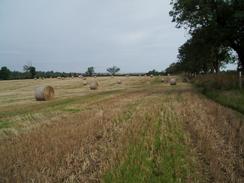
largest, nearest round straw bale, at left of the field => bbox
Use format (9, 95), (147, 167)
(35, 86), (54, 101)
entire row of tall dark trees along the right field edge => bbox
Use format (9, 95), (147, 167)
(166, 0), (244, 74)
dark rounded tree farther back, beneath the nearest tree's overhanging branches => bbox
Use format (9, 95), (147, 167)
(175, 31), (234, 74)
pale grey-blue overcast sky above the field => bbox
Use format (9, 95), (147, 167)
(0, 0), (186, 72)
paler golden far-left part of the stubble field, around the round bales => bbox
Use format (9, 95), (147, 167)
(0, 77), (148, 133)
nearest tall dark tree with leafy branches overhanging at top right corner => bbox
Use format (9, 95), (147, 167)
(170, 0), (244, 68)
